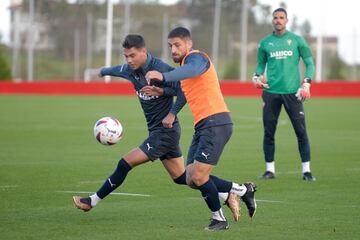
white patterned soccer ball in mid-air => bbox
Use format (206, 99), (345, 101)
(94, 117), (123, 145)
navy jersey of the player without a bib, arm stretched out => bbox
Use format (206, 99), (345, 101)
(101, 54), (186, 131)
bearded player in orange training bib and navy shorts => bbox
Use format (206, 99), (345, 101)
(146, 27), (256, 231)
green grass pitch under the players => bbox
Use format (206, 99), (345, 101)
(0, 95), (360, 240)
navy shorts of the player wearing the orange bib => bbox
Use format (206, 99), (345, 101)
(187, 123), (233, 165)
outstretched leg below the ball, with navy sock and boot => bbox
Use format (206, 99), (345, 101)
(73, 148), (149, 211)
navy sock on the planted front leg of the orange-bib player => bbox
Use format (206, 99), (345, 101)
(198, 179), (221, 212)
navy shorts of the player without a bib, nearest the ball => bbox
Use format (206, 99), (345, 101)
(139, 124), (182, 161)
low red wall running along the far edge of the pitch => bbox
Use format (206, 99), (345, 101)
(0, 81), (360, 97)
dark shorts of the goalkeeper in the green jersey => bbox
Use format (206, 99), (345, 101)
(262, 91), (305, 121)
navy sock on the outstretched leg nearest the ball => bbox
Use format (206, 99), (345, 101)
(96, 158), (131, 199)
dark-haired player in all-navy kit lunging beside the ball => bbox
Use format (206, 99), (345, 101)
(73, 34), (186, 211)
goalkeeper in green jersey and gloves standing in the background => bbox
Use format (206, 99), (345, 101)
(252, 8), (315, 181)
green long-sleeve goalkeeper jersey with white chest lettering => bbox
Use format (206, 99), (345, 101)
(255, 31), (315, 94)
